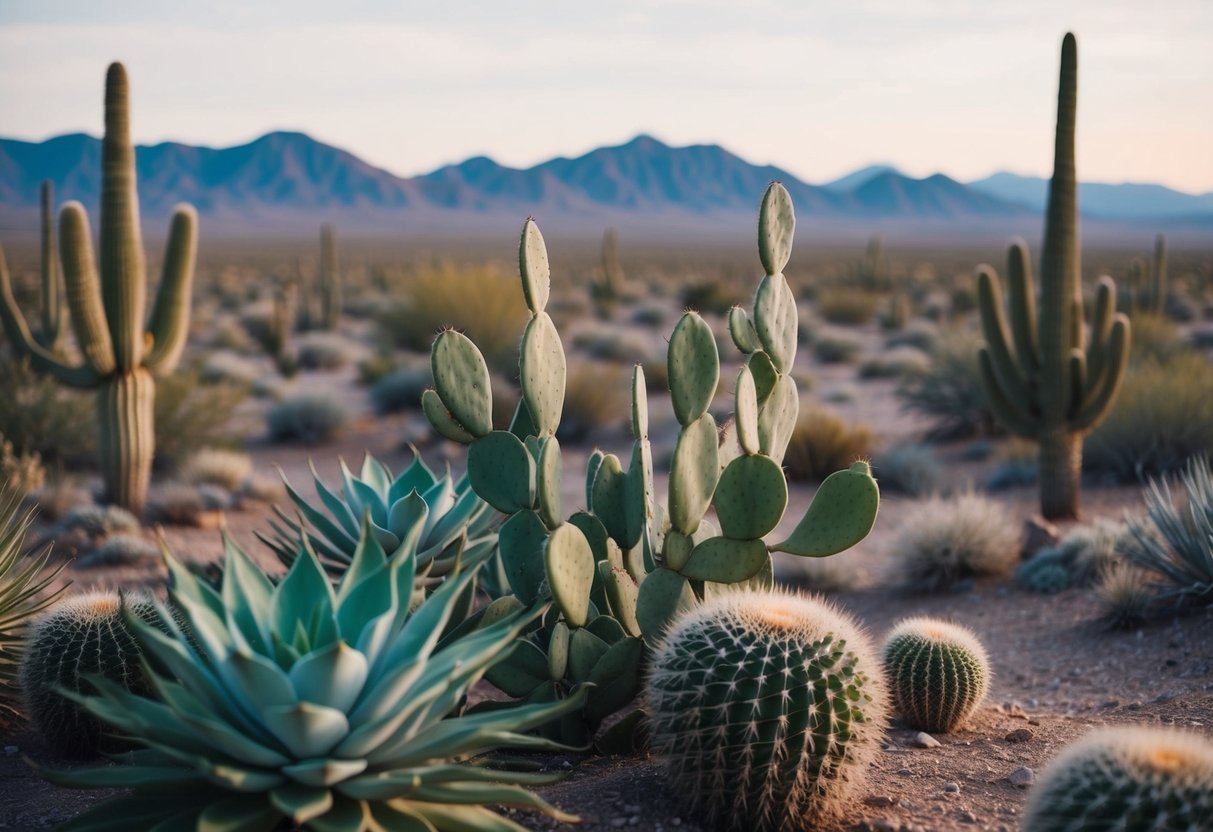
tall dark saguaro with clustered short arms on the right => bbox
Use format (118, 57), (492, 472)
(978, 34), (1129, 519)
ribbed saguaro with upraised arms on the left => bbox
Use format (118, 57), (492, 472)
(0, 63), (197, 513)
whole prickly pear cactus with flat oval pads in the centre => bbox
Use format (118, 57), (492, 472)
(422, 183), (879, 747)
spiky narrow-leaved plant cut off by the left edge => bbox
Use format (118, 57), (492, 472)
(0, 488), (67, 725)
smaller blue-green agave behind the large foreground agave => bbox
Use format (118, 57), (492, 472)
(257, 448), (503, 588)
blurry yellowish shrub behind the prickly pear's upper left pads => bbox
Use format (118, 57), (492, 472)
(377, 266), (526, 372)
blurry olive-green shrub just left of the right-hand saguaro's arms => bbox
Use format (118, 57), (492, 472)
(898, 330), (995, 438)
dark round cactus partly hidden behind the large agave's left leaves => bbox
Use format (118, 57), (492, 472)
(21, 591), (155, 758)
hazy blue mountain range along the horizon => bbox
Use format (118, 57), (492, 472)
(0, 132), (1213, 241)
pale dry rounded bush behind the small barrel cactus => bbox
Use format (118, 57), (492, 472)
(893, 491), (1020, 591)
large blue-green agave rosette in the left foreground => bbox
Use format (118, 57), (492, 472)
(41, 519), (585, 832)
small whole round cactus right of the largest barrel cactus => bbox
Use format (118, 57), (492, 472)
(884, 617), (990, 734)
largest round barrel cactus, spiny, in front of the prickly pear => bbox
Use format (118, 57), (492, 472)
(647, 591), (887, 832)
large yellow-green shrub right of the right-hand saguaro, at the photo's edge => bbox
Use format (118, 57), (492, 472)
(1082, 352), (1213, 481)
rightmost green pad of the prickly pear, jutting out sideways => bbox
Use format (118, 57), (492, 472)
(771, 462), (881, 558)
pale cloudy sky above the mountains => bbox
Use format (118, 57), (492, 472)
(0, 0), (1213, 193)
